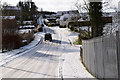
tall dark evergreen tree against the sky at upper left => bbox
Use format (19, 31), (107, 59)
(17, 0), (38, 24)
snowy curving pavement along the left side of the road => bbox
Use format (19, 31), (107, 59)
(0, 33), (44, 65)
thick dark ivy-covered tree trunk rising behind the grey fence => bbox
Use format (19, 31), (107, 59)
(89, 2), (103, 37)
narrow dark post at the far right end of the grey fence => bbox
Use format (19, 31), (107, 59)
(116, 31), (120, 80)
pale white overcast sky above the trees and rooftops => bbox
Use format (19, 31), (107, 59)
(2, 0), (120, 12)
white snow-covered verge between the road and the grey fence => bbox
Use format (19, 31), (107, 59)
(62, 46), (94, 78)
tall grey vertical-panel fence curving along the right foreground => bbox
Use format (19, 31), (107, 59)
(82, 31), (120, 78)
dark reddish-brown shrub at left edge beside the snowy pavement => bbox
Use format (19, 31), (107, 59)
(2, 34), (22, 50)
